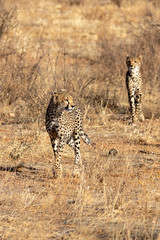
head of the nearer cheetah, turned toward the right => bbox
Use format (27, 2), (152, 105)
(52, 90), (75, 111)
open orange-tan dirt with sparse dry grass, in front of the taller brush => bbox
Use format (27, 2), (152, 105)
(0, 119), (160, 239)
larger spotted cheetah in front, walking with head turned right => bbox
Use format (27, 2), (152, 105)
(46, 90), (92, 178)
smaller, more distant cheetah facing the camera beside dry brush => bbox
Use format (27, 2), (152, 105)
(126, 55), (144, 123)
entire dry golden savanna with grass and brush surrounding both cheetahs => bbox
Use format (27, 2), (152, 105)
(0, 0), (160, 240)
